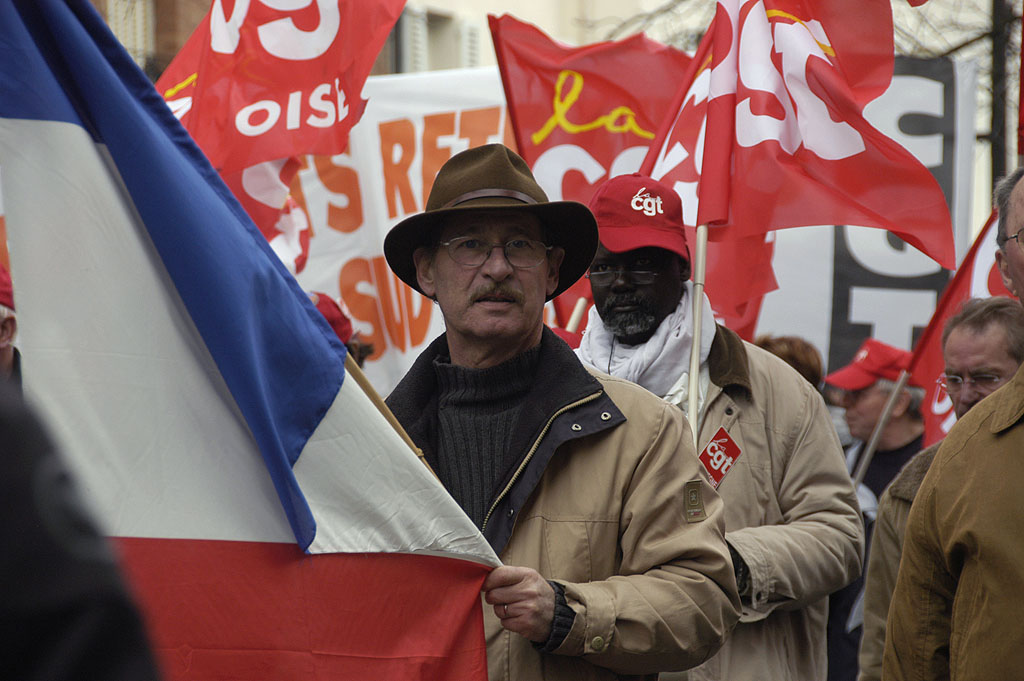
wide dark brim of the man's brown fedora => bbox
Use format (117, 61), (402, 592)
(384, 199), (597, 300)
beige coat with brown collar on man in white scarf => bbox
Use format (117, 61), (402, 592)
(689, 327), (864, 681)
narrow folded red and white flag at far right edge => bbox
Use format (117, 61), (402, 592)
(910, 211), (1011, 446)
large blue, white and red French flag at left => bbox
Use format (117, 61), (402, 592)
(0, 0), (498, 681)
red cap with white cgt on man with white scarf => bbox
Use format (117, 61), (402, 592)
(590, 173), (690, 262)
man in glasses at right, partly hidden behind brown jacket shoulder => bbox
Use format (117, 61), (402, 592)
(857, 298), (1024, 681)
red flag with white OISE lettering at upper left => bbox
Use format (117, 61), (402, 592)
(166, 0), (404, 172)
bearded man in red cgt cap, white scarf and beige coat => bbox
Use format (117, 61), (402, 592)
(578, 174), (863, 681)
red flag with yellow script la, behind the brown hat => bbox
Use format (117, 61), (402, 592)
(487, 14), (690, 333)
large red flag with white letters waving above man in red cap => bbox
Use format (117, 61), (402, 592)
(643, 0), (955, 270)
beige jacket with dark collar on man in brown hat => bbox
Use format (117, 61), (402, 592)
(388, 330), (739, 681)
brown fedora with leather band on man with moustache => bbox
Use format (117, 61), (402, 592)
(384, 144), (597, 300)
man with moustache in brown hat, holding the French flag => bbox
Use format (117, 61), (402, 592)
(384, 144), (738, 681)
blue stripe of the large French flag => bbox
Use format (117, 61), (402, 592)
(0, 0), (345, 548)
